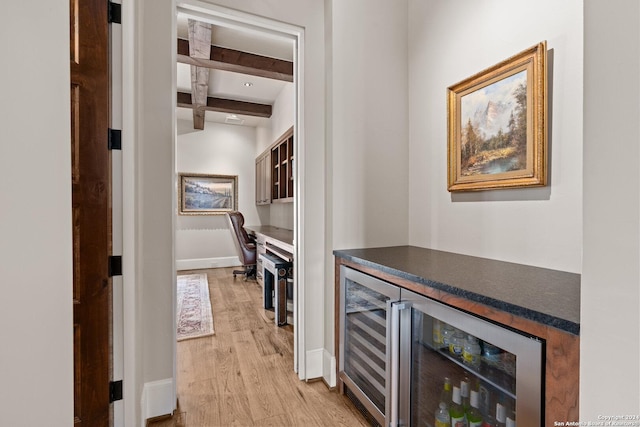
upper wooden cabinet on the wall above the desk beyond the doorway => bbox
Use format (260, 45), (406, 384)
(256, 127), (294, 205)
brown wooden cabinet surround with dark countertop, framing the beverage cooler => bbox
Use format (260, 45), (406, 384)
(333, 246), (580, 425)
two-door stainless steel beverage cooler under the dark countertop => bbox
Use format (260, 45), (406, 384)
(338, 266), (544, 427)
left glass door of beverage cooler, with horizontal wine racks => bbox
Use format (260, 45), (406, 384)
(338, 266), (400, 426)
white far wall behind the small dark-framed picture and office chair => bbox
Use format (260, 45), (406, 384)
(176, 120), (260, 269)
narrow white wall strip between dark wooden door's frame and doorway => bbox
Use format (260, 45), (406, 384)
(138, 0), (177, 418)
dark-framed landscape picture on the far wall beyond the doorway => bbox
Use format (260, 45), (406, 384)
(178, 173), (238, 215)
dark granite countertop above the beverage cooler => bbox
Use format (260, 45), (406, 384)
(333, 246), (580, 335)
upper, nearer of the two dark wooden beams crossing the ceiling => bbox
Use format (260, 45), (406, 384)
(177, 39), (293, 82)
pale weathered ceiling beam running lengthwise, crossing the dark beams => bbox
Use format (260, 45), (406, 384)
(189, 19), (211, 130)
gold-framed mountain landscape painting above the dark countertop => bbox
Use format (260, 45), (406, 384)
(447, 42), (547, 191)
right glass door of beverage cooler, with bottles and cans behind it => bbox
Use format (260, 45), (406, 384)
(392, 290), (543, 427)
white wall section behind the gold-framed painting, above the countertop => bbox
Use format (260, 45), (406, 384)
(409, 0), (583, 273)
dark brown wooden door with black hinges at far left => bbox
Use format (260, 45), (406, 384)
(70, 0), (111, 427)
